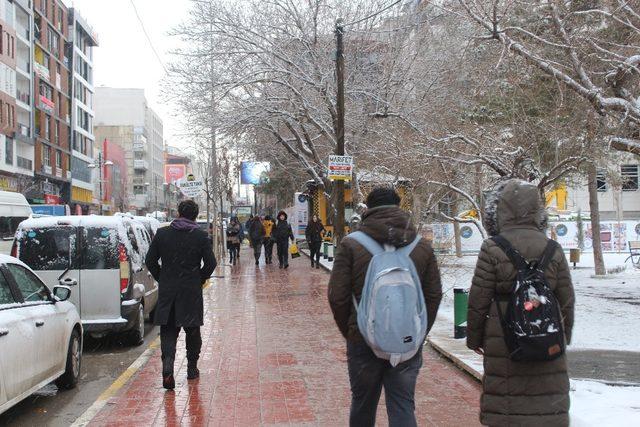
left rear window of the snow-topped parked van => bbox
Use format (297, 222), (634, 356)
(20, 227), (77, 270)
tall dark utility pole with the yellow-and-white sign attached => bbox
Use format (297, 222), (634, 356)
(333, 19), (345, 245)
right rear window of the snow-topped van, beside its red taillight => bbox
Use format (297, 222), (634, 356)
(82, 227), (120, 270)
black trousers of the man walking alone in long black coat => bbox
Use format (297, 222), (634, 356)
(160, 307), (202, 377)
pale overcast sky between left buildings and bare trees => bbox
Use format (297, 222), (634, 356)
(63, 0), (190, 147)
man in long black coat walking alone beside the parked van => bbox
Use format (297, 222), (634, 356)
(145, 200), (216, 390)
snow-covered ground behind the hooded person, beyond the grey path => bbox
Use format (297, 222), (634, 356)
(440, 253), (640, 352)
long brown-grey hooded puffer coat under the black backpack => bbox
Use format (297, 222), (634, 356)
(467, 180), (574, 427)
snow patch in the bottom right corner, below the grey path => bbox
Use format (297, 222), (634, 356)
(570, 380), (640, 427)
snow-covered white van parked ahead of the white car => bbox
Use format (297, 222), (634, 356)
(12, 215), (158, 345)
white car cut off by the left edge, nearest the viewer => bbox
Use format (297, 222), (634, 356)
(0, 255), (82, 414)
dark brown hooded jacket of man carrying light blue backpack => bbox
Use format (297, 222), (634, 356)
(329, 206), (442, 341)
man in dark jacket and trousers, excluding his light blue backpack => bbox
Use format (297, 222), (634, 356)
(328, 188), (442, 427)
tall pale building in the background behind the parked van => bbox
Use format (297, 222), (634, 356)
(94, 87), (166, 214)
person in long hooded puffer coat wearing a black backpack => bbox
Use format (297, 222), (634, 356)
(467, 179), (575, 426)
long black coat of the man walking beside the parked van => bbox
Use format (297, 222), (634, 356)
(145, 222), (216, 327)
